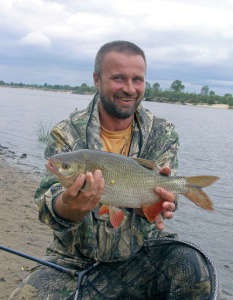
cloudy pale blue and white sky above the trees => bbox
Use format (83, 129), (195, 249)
(0, 0), (233, 95)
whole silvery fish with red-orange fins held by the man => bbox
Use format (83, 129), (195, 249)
(46, 149), (219, 228)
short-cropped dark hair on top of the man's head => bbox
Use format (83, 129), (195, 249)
(94, 41), (146, 77)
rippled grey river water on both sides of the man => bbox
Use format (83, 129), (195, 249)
(0, 88), (233, 300)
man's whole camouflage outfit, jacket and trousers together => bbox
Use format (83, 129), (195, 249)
(10, 94), (217, 300)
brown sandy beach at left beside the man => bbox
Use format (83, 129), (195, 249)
(0, 155), (52, 300)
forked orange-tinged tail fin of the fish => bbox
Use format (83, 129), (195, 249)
(183, 176), (218, 210)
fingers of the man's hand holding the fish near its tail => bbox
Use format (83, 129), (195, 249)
(155, 167), (176, 230)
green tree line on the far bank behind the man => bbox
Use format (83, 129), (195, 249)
(0, 80), (233, 108)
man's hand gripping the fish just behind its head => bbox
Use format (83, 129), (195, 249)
(55, 170), (104, 222)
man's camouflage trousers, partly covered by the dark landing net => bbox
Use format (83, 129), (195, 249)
(8, 239), (218, 300)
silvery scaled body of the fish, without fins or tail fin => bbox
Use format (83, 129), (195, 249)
(48, 150), (186, 208)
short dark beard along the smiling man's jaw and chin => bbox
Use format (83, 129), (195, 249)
(100, 95), (141, 119)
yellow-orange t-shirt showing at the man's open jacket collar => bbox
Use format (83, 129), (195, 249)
(100, 124), (132, 156)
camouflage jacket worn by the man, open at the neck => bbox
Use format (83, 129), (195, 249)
(35, 95), (178, 262)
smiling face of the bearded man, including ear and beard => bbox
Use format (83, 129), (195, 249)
(94, 51), (146, 119)
